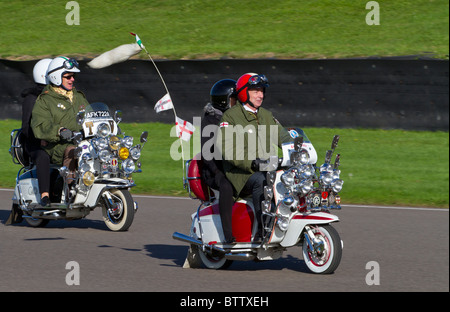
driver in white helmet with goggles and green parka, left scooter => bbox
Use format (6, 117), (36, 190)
(31, 56), (89, 184)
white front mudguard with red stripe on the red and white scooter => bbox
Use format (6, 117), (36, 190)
(280, 212), (339, 247)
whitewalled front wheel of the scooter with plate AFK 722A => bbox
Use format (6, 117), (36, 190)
(102, 189), (134, 232)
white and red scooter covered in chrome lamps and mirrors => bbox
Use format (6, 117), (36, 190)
(173, 128), (343, 274)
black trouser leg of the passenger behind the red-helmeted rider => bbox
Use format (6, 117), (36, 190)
(210, 174), (234, 241)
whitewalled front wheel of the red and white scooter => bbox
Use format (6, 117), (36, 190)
(302, 225), (342, 274)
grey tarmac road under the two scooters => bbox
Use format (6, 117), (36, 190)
(0, 189), (449, 293)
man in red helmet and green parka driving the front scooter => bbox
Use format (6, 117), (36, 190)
(220, 73), (291, 241)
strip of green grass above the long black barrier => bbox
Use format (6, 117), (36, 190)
(0, 0), (449, 59)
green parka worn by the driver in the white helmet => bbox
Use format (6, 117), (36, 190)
(31, 85), (89, 164)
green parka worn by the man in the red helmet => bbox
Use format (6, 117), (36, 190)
(218, 104), (292, 196)
